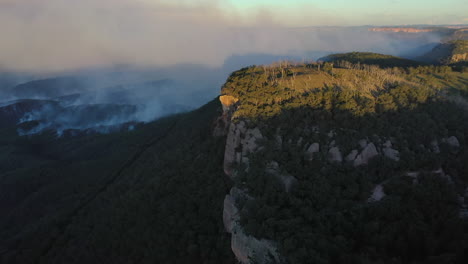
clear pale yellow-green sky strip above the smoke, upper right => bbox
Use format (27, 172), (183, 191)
(191, 0), (468, 26)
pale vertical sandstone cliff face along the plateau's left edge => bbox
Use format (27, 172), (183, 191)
(220, 96), (280, 264)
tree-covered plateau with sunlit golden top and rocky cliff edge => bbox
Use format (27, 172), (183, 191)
(217, 57), (468, 263)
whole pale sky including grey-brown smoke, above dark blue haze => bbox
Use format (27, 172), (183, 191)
(0, 0), (468, 72)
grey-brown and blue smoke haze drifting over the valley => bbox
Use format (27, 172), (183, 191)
(0, 0), (460, 134)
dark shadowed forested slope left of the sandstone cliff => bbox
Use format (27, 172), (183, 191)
(0, 98), (234, 264)
